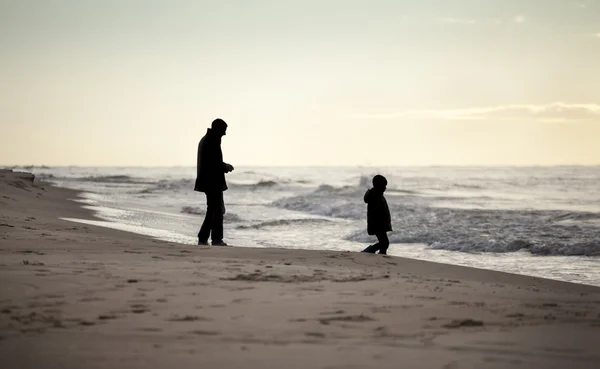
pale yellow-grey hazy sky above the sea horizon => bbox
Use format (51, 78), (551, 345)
(0, 0), (600, 166)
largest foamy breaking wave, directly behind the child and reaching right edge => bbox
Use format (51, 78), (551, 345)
(272, 179), (600, 256)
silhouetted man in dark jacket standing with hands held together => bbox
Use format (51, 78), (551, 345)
(194, 119), (233, 246)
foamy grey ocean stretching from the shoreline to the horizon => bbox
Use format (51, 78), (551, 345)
(14, 166), (600, 286)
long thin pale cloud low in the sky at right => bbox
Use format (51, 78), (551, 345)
(344, 102), (600, 122)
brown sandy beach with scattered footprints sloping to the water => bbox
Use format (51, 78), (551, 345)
(0, 171), (600, 369)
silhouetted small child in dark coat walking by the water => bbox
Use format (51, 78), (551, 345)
(362, 174), (392, 255)
